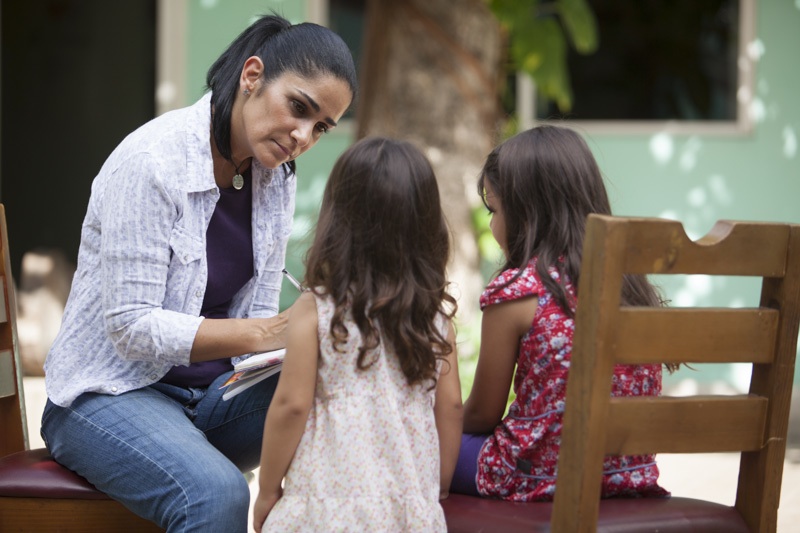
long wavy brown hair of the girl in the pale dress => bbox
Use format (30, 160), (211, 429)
(305, 137), (456, 384)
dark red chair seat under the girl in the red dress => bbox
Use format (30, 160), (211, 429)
(442, 494), (750, 533)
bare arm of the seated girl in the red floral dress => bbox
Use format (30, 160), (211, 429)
(464, 296), (539, 434)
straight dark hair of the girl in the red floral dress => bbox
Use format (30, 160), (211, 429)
(478, 126), (663, 316)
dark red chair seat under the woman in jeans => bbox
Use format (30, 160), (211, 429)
(0, 448), (110, 500)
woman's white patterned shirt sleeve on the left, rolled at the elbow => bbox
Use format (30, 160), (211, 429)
(95, 153), (205, 364)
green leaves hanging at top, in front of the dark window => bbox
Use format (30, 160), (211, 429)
(489, 0), (598, 111)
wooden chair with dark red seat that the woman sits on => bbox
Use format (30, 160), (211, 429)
(0, 204), (163, 533)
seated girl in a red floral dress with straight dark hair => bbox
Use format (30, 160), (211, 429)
(451, 126), (669, 501)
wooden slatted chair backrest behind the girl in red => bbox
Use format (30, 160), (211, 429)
(551, 215), (800, 532)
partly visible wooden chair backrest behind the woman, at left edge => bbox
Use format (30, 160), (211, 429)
(0, 204), (28, 457)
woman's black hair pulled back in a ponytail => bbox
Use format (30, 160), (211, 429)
(206, 15), (358, 172)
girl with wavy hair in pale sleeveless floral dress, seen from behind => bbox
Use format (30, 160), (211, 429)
(253, 138), (462, 533)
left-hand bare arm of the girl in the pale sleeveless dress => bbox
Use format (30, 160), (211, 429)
(253, 293), (319, 532)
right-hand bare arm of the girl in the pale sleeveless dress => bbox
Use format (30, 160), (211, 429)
(433, 323), (463, 498)
